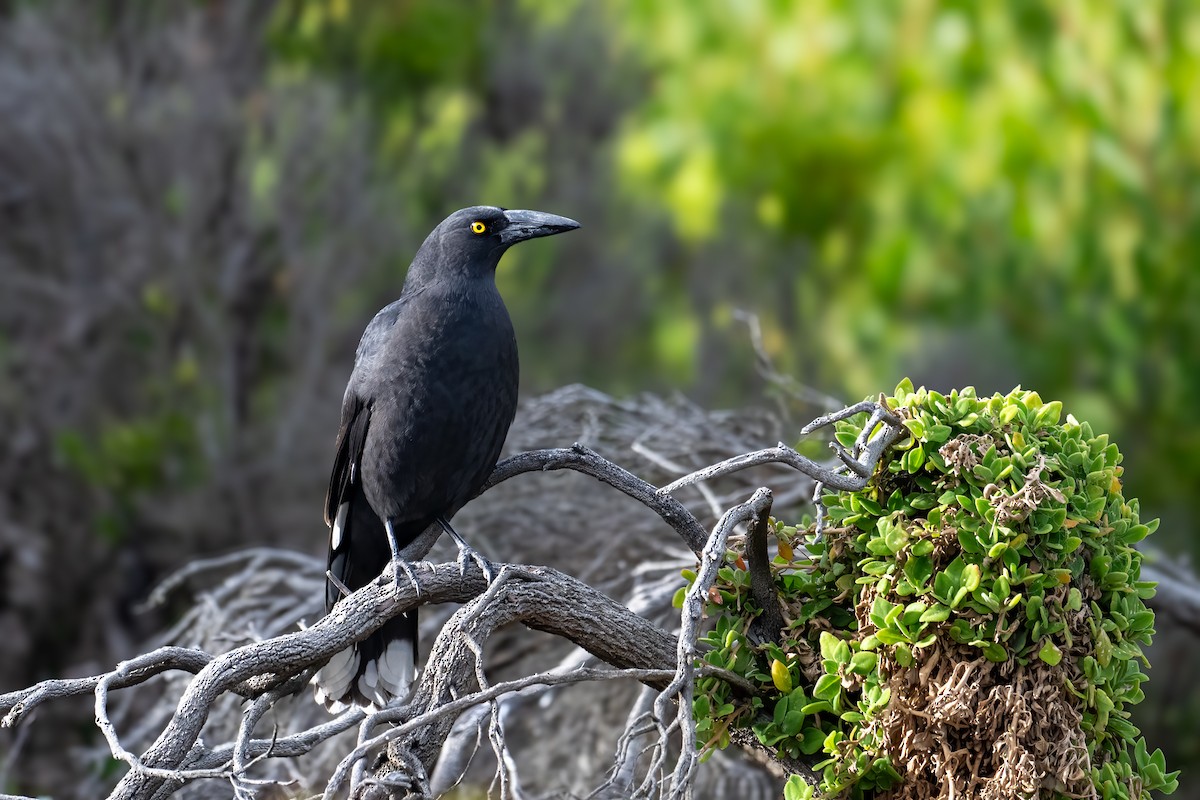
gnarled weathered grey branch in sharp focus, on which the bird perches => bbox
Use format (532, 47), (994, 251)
(0, 403), (902, 800)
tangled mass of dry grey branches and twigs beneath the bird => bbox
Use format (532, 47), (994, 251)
(0, 387), (1200, 798)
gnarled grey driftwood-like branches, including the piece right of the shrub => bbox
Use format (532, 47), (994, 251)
(0, 395), (1200, 800)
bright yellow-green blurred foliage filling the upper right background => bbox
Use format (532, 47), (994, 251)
(620, 0), (1200, 520)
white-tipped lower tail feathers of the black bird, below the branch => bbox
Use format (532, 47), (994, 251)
(312, 608), (418, 714)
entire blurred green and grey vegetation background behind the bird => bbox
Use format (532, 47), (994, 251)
(0, 0), (1200, 796)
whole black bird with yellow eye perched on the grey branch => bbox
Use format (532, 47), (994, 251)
(312, 205), (580, 712)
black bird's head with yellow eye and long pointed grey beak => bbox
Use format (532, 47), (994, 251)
(409, 205), (580, 286)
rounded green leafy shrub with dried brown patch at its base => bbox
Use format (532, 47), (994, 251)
(686, 381), (1177, 800)
